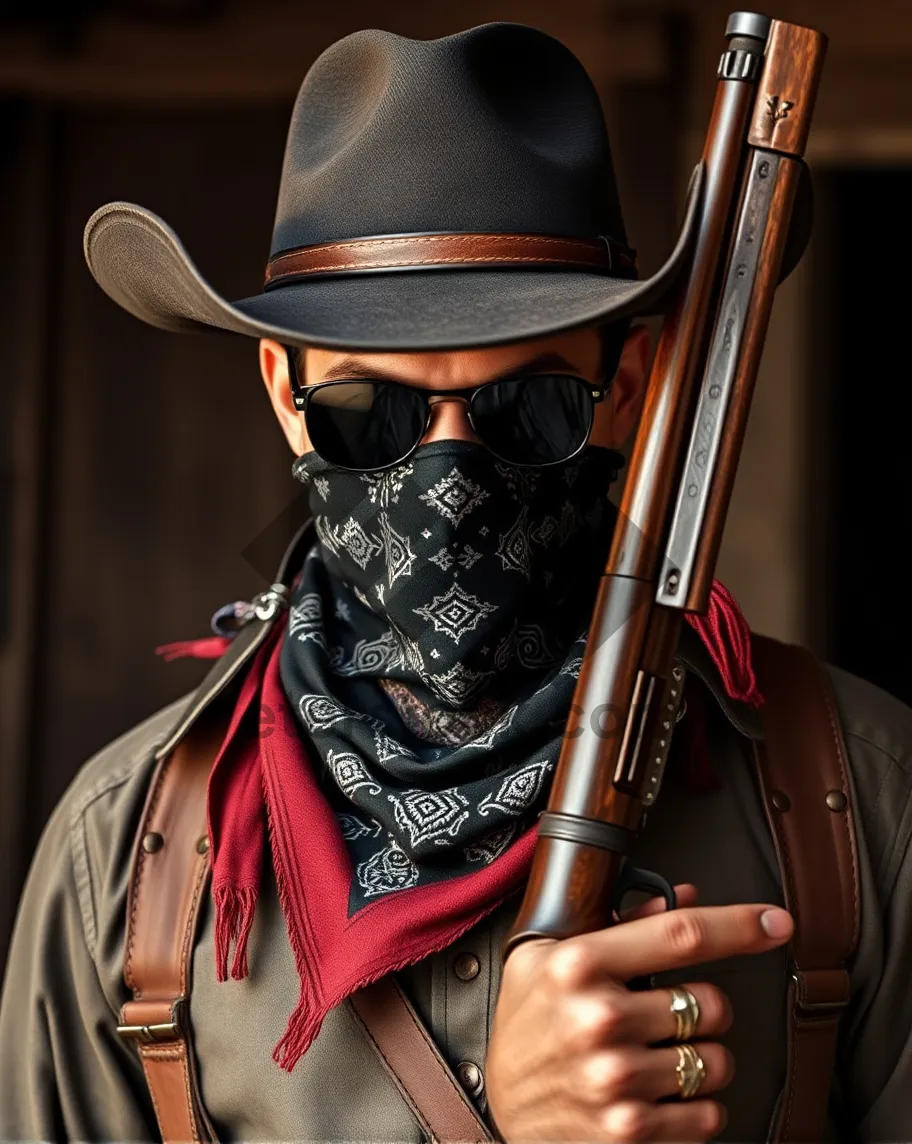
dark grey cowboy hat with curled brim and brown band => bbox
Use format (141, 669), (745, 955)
(85, 23), (699, 350)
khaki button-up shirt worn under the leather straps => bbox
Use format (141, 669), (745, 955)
(0, 639), (912, 1142)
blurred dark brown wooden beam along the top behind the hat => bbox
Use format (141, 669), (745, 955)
(0, 0), (681, 104)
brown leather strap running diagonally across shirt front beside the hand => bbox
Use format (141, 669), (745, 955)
(350, 977), (493, 1144)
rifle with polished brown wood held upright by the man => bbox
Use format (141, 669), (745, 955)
(506, 13), (826, 953)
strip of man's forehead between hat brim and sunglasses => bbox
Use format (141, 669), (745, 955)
(307, 327), (600, 386)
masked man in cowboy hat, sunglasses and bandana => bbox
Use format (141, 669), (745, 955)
(0, 24), (912, 1141)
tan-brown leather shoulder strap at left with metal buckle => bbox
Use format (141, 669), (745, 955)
(118, 713), (227, 1142)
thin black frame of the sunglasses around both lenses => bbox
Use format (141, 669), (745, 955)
(286, 347), (610, 472)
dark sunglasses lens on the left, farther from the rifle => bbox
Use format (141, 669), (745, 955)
(306, 381), (427, 470)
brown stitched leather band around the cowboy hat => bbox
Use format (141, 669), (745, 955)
(265, 235), (636, 289)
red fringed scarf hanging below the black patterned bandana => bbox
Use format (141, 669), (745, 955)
(159, 582), (762, 1070)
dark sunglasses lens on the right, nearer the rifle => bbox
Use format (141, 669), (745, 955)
(471, 374), (593, 464)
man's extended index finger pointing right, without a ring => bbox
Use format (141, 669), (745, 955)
(554, 905), (793, 985)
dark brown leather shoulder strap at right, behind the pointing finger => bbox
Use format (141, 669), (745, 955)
(753, 636), (861, 1144)
